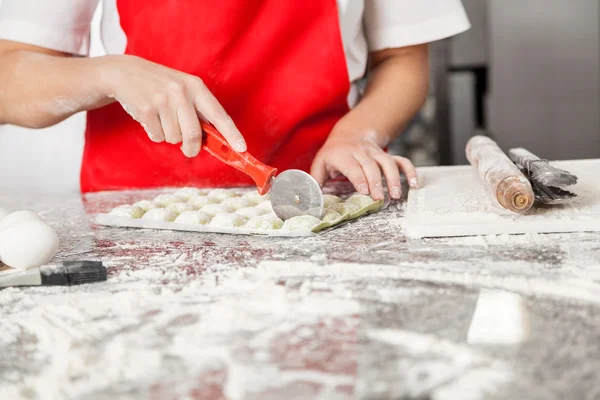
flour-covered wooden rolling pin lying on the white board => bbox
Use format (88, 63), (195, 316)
(466, 136), (535, 213)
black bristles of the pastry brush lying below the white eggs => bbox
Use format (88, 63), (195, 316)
(40, 261), (107, 286)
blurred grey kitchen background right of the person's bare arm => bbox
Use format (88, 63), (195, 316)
(448, 0), (600, 164)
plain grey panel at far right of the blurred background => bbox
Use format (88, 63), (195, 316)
(487, 0), (600, 159)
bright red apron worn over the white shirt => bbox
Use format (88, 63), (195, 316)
(81, 0), (350, 192)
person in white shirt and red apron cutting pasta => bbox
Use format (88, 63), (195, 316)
(0, 0), (469, 199)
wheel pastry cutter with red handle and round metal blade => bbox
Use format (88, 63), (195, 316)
(200, 121), (323, 221)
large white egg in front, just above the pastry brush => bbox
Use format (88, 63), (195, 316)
(0, 219), (58, 269)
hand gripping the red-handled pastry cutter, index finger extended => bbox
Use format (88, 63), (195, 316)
(99, 55), (246, 157)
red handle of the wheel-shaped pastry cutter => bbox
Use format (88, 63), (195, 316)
(200, 121), (277, 195)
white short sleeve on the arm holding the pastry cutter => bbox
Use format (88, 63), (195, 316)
(0, 0), (98, 55)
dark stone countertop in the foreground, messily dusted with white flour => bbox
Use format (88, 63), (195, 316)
(0, 180), (600, 400)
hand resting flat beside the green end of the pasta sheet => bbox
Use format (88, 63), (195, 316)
(311, 129), (418, 200)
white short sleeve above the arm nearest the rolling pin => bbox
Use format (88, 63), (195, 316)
(364, 0), (471, 51)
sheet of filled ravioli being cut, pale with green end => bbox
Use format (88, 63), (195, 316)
(95, 188), (383, 236)
